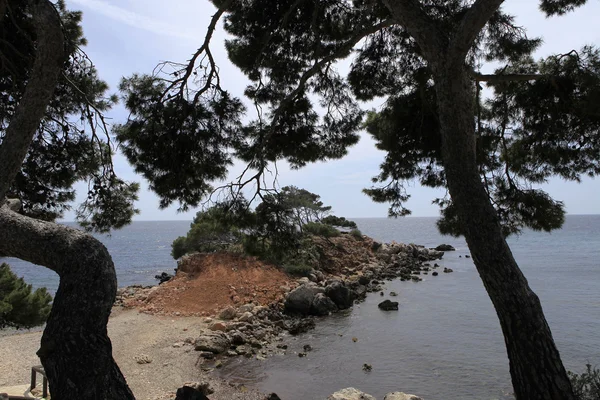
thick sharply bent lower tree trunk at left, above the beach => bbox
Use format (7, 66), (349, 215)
(0, 207), (134, 400)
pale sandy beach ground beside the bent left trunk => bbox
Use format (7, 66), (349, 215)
(0, 308), (264, 400)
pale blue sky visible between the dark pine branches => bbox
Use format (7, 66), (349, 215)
(59, 0), (600, 221)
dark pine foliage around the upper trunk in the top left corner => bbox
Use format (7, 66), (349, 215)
(0, 0), (138, 232)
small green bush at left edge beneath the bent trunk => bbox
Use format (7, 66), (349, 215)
(0, 264), (52, 328)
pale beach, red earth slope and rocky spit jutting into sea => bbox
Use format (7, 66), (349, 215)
(0, 234), (451, 400)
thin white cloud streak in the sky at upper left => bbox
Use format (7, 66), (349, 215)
(71, 0), (198, 41)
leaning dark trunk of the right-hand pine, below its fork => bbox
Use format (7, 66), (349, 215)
(434, 63), (574, 400)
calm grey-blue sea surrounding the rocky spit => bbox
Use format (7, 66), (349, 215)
(0, 215), (600, 400)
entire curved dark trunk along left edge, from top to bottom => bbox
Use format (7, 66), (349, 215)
(0, 0), (134, 400)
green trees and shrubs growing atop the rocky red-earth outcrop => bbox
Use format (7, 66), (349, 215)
(171, 186), (360, 276)
